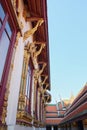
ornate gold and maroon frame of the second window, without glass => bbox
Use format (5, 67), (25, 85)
(16, 52), (34, 124)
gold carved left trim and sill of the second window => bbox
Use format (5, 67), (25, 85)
(16, 46), (33, 125)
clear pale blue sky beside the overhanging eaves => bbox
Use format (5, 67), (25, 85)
(47, 0), (87, 103)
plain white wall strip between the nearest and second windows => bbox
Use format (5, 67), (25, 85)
(6, 38), (24, 125)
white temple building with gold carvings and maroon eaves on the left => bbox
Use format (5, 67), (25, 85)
(0, 0), (51, 130)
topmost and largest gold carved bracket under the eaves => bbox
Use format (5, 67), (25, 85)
(24, 18), (44, 40)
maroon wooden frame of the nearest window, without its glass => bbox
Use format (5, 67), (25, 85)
(0, 0), (17, 123)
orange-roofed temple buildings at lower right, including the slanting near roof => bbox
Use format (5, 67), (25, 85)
(46, 83), (87, 130)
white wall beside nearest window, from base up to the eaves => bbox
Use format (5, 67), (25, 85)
(6, 0), (33, 130)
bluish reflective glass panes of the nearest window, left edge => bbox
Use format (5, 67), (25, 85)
(0, 3), (13, 84)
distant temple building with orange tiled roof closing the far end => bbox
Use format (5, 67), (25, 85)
(46, 95), (74, 130)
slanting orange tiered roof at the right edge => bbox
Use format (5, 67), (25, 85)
(61, 84), (87, 123)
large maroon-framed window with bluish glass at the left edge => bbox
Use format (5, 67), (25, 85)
(0, 0), (17, 122)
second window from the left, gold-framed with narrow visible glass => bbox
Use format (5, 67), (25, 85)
(17, 52), (33, 119)
